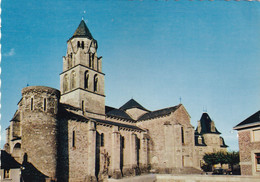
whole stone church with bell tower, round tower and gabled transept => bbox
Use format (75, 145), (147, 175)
(2, 20), (226, 182)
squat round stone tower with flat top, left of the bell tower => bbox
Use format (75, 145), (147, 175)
(19, 86), (60, 180)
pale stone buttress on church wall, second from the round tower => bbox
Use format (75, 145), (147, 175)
(111, 126), (122, 179)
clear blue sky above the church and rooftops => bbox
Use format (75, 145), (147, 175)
(0, 0), (260, 151)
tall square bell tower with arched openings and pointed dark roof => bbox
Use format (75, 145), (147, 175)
(60, 20), (105, 114)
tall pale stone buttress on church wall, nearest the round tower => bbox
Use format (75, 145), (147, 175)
(87, 121), (96, 181)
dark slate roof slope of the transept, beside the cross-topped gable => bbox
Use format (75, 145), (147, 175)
(138, 104), (181, 121)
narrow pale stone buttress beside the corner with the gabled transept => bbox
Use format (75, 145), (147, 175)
(140, 132), (148, 172)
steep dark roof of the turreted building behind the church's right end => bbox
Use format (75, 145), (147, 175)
(195, 113), (221, 134)
